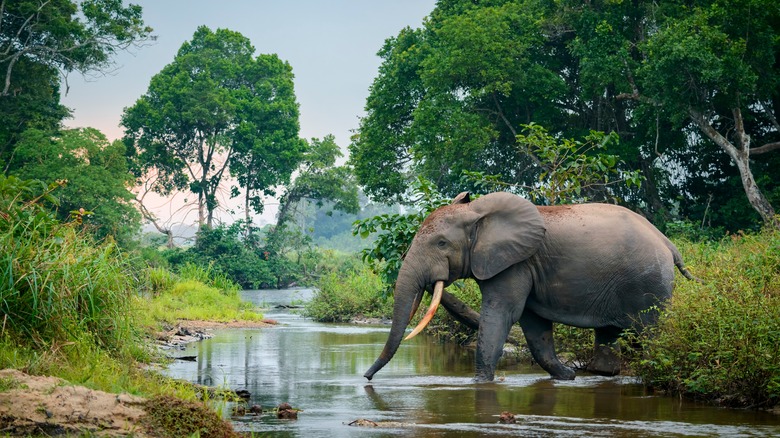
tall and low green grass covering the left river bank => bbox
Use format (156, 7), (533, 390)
(0, 175), (262, 436)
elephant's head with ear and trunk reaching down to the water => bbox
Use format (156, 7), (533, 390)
(364, 192), (545, 380)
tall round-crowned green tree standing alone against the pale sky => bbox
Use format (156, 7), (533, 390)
(122, 26), (301, 228)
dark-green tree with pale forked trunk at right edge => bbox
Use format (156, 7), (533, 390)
(631, 1), (780, 228)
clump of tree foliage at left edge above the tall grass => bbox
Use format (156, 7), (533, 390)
(0, 0), (153, 243)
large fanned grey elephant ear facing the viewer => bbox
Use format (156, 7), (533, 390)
(471, 192), (546, 280)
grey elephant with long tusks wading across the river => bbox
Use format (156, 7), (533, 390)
(364, 192), (695, 382)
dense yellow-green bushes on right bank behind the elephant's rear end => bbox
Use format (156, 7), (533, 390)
(632, 231), (780, 407)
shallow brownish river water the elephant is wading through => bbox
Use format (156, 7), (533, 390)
(167, 289), (780, 437)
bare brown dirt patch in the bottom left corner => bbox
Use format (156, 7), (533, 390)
(0, 369), (150, 437)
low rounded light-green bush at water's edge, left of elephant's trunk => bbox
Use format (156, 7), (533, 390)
(304, 267), (393, 322)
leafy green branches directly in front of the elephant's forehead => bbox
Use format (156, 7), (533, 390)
(352, 178), (450, 298)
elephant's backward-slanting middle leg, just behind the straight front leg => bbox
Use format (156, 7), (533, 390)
(520, 309), (575, 380)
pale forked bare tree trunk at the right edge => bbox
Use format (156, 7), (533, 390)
(689, 108), (780, 229)
